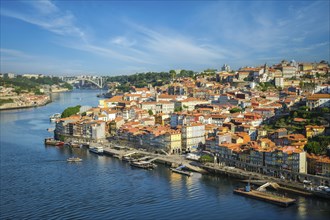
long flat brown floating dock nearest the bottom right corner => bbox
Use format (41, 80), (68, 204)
(234, 188), (296, 207)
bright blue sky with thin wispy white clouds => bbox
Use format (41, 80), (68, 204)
(0, 0), (330, 75)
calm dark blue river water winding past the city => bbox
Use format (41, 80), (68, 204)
(0, 90), (330, 219)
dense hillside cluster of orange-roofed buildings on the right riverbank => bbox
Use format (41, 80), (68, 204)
(55, 61), (330, 179)
